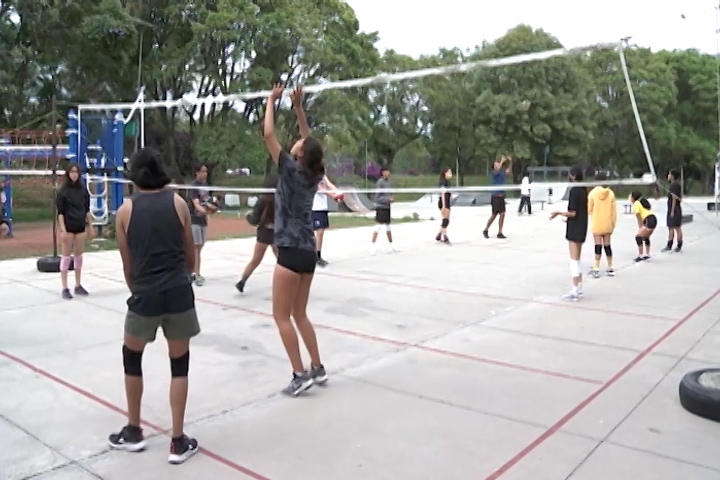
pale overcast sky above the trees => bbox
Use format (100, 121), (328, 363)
(346, 0), (717, 56)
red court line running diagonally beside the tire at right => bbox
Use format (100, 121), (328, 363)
(485, 289), (720, 480)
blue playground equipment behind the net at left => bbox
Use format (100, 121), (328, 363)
(0, 110), (125, 234)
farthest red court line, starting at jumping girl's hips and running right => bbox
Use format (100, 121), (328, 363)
(316, 271), (676, 322)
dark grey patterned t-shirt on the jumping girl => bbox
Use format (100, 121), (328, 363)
(275, 152), (319, 252)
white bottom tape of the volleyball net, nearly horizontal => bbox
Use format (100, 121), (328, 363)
(0, 170), (655, 194)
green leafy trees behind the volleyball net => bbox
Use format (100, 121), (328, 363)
(0, 0), (718, 193)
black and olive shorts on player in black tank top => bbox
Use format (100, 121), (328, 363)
(125, 283), (200, 342)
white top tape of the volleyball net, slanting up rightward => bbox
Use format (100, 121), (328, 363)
(78, 42), (622, 112)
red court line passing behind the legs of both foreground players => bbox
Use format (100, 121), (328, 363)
(86, 272), (603, 385)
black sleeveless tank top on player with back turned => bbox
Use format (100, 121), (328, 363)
(127, 190), (190, 294)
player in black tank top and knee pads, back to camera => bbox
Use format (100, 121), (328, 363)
(109, 148), (200, 464)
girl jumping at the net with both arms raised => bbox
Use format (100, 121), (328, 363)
(263, 85), (328, 396)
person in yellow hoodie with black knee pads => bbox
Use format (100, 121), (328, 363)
(588, 172), (617, 278)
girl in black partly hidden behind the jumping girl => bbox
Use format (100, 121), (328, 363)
(235, 175), (278, 293)
